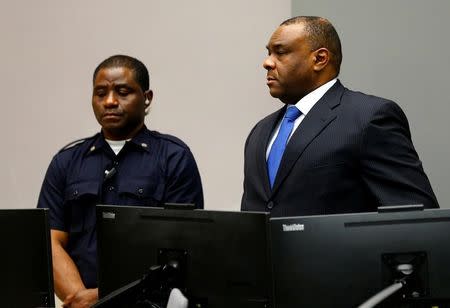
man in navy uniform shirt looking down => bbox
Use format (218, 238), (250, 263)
(38, 55), (203, 307)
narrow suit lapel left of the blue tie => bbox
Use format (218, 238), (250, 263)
(250, 107), (286, 196)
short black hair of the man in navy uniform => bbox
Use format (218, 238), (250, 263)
(93, 55), (150, 92)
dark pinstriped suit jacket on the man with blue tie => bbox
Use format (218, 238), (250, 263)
(241, 81), (438, 216)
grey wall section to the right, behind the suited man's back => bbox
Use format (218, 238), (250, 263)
(292, 0), (450, 208)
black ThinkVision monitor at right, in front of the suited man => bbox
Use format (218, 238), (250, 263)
(270, 209), (450, 308)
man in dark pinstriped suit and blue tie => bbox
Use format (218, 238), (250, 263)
(241, 16), (438, 216)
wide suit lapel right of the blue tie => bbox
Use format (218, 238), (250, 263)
(272, 80), (344, 194)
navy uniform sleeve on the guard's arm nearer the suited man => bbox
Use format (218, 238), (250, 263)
(165, 148), (203, 209)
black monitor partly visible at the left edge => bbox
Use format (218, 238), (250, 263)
(0, 209), (55, 307)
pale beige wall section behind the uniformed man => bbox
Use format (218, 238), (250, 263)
(0, 0), (290, 210)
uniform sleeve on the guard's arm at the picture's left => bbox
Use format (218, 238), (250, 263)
(37, 155), (67, 231)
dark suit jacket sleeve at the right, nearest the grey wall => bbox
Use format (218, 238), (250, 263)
(361, 101), (439, 208)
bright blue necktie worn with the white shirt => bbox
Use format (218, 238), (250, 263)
(267, 106), (302, 187)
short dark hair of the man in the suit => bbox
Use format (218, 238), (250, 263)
(280, 16), (342, 74)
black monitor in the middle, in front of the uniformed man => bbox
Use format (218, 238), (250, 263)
(97, 206), (272, 308)
